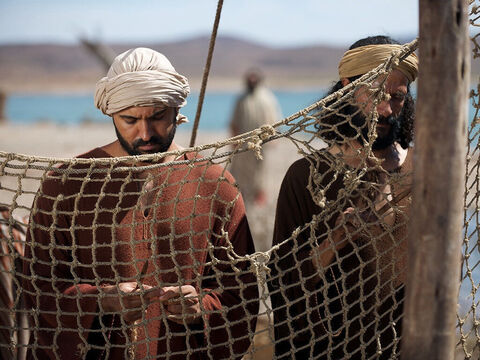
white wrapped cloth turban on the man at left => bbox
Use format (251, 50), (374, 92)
(95, 48), (190, 123)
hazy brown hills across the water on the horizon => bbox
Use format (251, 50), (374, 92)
(0, 36), (345, 92)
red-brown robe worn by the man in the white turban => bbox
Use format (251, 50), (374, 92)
(24, 148), (258, 359)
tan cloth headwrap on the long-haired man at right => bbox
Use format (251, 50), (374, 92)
(338, 44), (418, 82)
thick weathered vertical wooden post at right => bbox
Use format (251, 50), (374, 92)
(402, 0), (470, 360)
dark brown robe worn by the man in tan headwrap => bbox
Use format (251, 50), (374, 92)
(268, 151), (406, 359)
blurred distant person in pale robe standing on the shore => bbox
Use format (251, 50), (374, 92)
(230, 70), (281, 207)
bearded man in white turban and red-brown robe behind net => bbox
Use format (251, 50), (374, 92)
(24, 48), (258, 359)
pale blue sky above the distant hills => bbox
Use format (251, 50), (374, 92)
(0, 0), (418, 47)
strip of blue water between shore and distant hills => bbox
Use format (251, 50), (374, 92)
(6, 90), (324, 130)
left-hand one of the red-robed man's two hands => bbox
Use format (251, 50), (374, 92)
(101, 281), (162, 324)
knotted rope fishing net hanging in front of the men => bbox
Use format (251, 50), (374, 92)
(0, 4), (480, 359)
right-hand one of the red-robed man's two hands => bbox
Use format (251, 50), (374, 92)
(159, 285), (202, 324)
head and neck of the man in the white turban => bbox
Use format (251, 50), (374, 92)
(95, 48), (190, 161)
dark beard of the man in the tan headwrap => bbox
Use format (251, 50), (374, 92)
(346, 105), (404, 150)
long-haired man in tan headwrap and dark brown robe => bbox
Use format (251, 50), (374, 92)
(269, 36), (418, 359)
